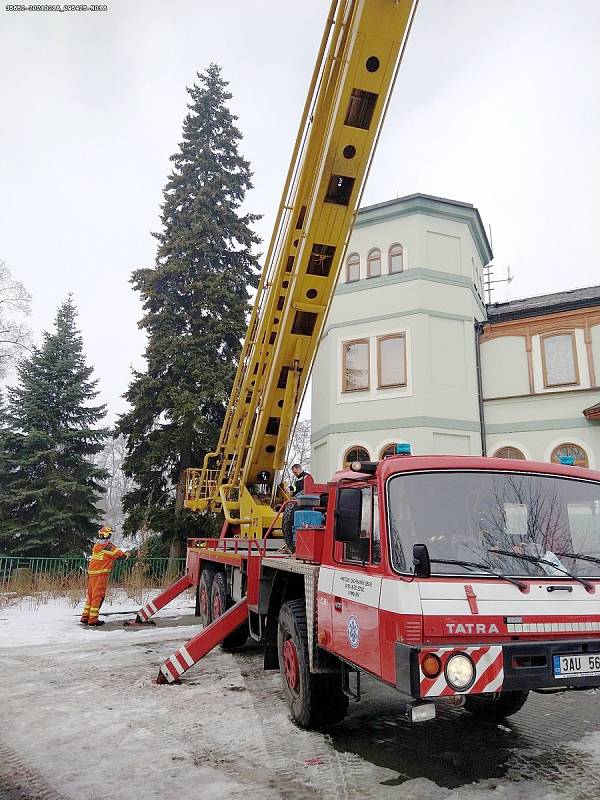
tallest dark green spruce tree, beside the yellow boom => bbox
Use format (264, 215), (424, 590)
(118, 64), (259, 555)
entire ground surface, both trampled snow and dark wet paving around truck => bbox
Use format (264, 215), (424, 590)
(0, 598), (600, 800)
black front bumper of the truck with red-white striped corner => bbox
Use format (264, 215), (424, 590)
(395, 639), (600, 699)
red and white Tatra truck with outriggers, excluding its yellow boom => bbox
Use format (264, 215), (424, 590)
(139, 455), (600, 727)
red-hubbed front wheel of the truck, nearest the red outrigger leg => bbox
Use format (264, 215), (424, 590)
(277, 600), (348, 730)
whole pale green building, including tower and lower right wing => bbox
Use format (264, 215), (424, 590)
(311, 194), (600, 480)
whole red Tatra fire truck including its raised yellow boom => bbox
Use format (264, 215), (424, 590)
(129, 0), (600, 727)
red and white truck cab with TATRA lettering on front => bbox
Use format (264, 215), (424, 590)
(308, 456), (600, 720)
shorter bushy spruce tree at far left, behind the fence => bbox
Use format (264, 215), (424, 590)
(0, 297), (108, 555)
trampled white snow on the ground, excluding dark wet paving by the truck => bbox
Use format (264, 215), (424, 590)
(0, 596), (600, 800)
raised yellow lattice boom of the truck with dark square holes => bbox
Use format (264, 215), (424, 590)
(185, 0), (418, 538)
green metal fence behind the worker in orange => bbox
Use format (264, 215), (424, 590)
(0, 555), (185, 585)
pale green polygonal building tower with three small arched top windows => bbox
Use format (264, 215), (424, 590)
(311, 194), (492, 480)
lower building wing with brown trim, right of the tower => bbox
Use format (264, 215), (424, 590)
(480, 286), (600, 469)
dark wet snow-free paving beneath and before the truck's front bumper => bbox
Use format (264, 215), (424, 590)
(236, 654), (600, 800)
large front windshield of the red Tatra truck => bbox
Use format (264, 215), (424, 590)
(387, 471), (600, 579)
